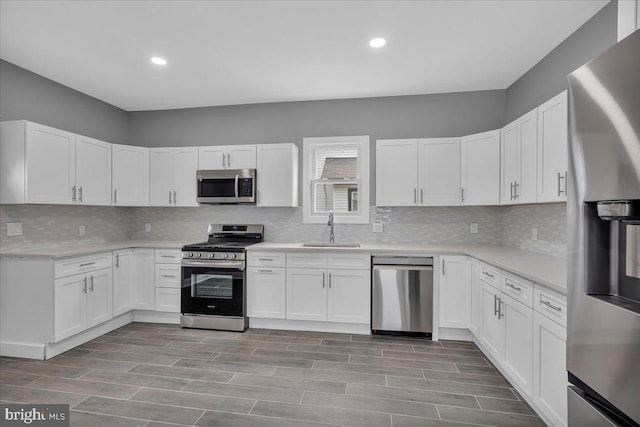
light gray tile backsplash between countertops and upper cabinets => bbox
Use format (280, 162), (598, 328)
(0, 204), (566, 256)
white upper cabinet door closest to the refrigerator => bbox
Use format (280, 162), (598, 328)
(538, 91), (568, 202)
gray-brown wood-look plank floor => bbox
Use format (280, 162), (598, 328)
(0, 323), (544, 427)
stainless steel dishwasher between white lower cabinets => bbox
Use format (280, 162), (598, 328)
(371, 257), (433, 337)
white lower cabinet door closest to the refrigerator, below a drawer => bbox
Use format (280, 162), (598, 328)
(533, 313), (568, 426)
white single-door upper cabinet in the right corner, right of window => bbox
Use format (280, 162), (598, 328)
(460, 130), (500, 206)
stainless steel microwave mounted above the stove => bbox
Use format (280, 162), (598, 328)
(196, 169), (256, 204)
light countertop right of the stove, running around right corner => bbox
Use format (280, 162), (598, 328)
(248, 243), (567, 295)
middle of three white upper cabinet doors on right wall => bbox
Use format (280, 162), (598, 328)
(515, 108), (538, 203)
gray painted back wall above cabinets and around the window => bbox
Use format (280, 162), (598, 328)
(130, 90), (506, 204)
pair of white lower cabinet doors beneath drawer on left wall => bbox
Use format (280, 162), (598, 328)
(54, 268), (113, 342)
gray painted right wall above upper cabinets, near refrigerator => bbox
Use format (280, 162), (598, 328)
(506, 0), (618, 123)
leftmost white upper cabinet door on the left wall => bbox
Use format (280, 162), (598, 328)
(26, 122), (76, 205)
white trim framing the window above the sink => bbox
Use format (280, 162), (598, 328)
(302, 135), (370, 224)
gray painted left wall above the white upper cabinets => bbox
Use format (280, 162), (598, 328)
(0, 60), (129, 144)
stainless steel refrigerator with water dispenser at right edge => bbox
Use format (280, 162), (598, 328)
(567, 31), (640, 427)
